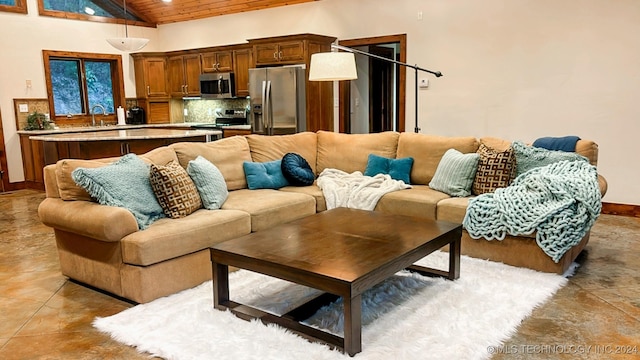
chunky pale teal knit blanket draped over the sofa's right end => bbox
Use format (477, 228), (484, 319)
(462, 160), (602, 263)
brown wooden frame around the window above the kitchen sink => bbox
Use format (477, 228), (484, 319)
(42, 50), (126, 126)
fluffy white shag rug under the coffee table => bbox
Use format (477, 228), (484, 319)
(94, 252), (567, 360)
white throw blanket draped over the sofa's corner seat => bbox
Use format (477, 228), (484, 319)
(317, 169), (411, 210)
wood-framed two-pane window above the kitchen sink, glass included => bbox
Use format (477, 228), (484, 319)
(43, 50), (125, 124)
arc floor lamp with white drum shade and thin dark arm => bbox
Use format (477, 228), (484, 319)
(309, 44), (442, 133)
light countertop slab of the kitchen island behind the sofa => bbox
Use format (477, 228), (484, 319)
(28, 125), (222, 141)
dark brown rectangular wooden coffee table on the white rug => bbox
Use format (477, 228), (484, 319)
(211, 208), (462, 356)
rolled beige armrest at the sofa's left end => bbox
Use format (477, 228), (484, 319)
(38, 198), (138, 241)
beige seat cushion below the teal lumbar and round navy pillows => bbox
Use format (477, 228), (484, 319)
(222, 189), (316, 231)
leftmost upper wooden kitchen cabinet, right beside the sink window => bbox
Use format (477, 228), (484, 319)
(131, 53), (169, 99)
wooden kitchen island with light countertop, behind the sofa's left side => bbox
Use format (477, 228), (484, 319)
(19, 125), (222, 190)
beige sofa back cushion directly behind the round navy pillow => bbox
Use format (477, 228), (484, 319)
(246, 132), (318, 173)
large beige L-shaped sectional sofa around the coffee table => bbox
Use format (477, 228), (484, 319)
(38, 131), (606, 303)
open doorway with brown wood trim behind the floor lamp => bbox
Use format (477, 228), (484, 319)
(338, 34), (406, 134)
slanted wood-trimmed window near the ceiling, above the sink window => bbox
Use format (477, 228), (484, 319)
(37, 0), (155, 26)
